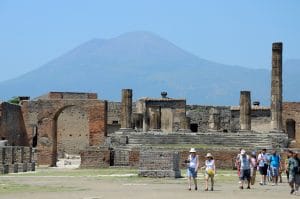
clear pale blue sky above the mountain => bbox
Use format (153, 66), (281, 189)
(0, 0), (300, 81)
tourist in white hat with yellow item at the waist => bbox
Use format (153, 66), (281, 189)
(201, 153), (216, 191)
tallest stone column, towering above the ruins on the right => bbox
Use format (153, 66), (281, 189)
(271, 42), (282, 131)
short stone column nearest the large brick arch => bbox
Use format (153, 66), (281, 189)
(121, 89), (132, 129)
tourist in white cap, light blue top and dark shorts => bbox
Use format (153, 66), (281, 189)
(239, 149), (251, 189)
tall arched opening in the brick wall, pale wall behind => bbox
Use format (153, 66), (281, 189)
(53, 106), (89, 168)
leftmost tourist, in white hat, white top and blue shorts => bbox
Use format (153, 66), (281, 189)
(186, 148), (199, 190)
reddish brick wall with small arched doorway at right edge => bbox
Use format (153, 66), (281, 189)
(282, 102), (300, 143)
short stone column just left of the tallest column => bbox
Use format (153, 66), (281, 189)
(240, 91), (251, 131)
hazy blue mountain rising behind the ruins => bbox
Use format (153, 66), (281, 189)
(0, 32), (300, 105)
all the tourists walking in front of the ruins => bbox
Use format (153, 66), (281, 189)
(185, 148), (300, 194)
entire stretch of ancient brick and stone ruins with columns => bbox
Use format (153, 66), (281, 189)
(0, 43), (300, 177)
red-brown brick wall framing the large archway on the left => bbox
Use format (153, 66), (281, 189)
(23, 99), (107, 165)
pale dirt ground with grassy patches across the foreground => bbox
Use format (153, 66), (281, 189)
(0, 171), (300, 199)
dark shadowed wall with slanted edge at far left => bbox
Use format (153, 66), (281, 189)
(0, 102), (29, 146)
